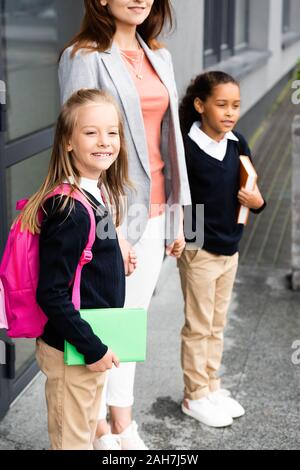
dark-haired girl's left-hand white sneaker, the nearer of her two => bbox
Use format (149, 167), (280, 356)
(181, 397), (233, 428)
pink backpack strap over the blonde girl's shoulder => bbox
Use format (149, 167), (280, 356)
(47, 183), (96, 310)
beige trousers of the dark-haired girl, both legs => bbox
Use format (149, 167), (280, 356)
(178, 250), (238, 400)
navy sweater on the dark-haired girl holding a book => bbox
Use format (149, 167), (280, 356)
(185, 132), (266, 256)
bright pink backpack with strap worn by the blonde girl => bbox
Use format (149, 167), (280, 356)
(0, 184), (96, 338)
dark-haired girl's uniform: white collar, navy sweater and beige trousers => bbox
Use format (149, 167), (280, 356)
(178, 122), (266, 400)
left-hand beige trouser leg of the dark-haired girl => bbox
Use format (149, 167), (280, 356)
(178, 249), (222, 400)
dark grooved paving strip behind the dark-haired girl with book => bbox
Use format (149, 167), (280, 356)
(240, 82), (300, 269)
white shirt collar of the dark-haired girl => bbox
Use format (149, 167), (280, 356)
(189, 121), (239, 161)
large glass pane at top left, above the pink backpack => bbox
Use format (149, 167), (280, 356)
(3, 0), (83, 141)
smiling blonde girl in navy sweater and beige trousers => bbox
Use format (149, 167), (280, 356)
(22, 90), (135, 450)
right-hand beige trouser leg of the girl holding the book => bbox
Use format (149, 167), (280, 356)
(207, 253), (238, 392)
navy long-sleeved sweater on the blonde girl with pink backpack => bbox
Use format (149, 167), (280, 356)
(37, 192), (125, 364)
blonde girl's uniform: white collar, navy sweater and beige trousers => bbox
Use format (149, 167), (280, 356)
(37, 178), (125, 450)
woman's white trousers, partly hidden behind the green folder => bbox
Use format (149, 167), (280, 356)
(99, 214), (165, 419)
